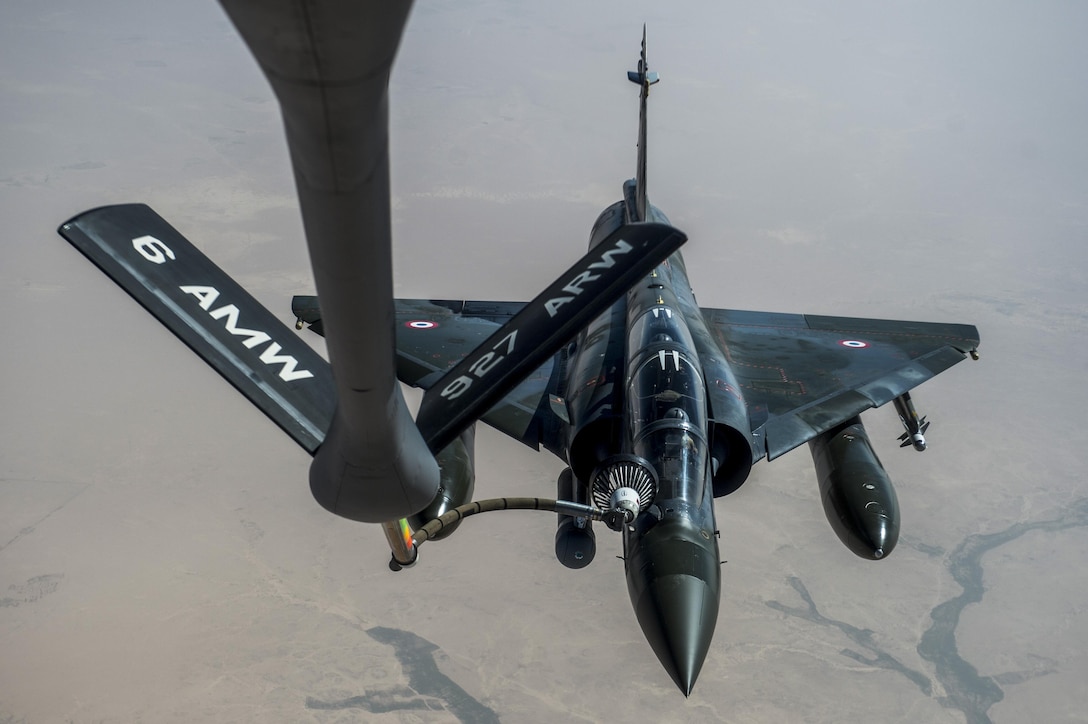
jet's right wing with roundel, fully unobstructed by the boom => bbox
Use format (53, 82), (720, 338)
(702, 309), (978, 459)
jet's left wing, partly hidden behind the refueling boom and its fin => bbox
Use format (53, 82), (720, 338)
(292, 296), (561, 451)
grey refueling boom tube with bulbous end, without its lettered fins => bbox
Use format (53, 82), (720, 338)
(223, 0), (438, 523)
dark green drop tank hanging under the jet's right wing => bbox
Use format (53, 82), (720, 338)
(808, 417), (899, 561)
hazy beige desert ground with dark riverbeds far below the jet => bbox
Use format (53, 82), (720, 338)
(0, 0), (1088, 722)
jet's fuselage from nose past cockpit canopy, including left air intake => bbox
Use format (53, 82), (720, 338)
(567, 182), (721, 694)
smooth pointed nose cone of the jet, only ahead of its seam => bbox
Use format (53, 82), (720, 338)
(635, 574), (718, 697)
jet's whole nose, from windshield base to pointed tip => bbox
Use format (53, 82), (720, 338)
(628, 521), (721, 696)
